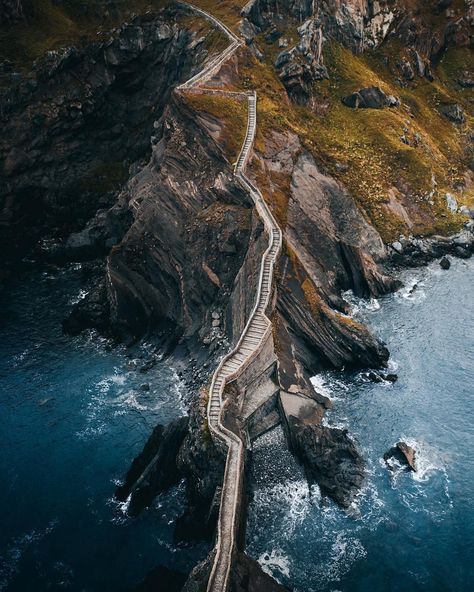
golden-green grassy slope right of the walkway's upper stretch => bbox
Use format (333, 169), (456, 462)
(228, 42), (473, 241)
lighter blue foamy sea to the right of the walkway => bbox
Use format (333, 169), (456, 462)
(247, 260), (474, 592)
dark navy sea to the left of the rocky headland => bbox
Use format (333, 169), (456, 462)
(0, 265), (206, 592)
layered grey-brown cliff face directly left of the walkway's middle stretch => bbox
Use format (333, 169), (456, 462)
(107, 95), (261, 344)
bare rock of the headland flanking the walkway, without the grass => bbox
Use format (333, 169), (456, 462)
(0, 0), (474, 592)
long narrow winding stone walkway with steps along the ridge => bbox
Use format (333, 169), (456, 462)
(179, 2), (282, 592)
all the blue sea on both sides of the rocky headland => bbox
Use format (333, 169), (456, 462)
(0, 261), (474, 592)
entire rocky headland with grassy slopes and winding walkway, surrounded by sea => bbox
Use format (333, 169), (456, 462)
(0, 0), (474, 592)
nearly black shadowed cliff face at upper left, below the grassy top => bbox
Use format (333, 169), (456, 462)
(0, 8), (217, 278)
